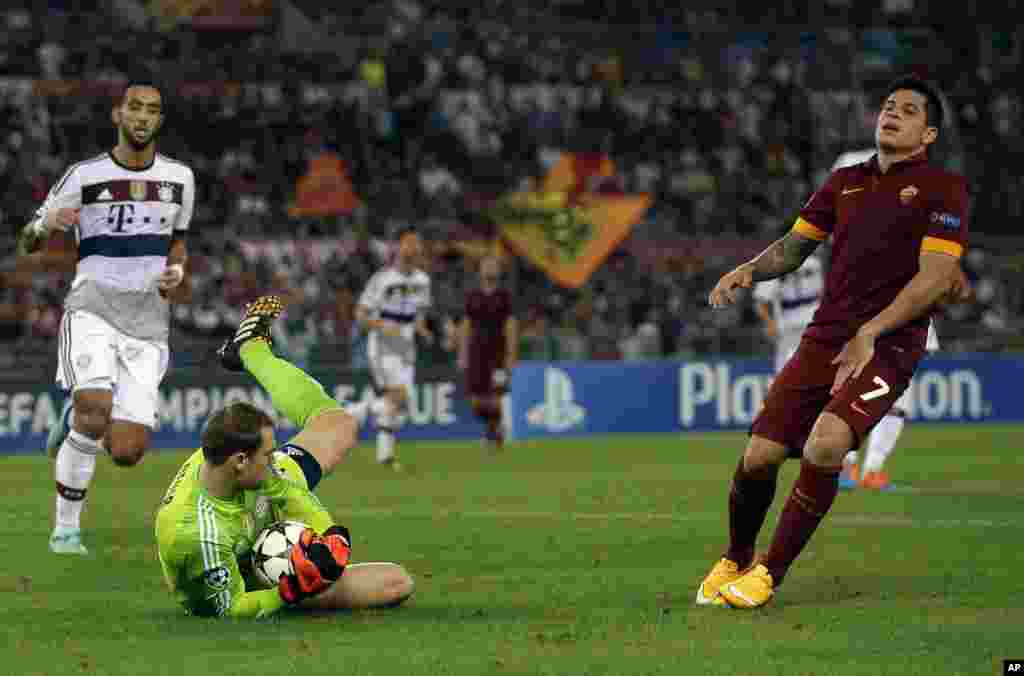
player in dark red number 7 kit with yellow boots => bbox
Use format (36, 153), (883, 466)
(696, 78), (968, 608)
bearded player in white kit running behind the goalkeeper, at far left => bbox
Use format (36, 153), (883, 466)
(18, 84), (196, 554)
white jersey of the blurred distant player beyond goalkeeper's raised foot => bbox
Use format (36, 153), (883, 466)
(359, 267), (431, 362)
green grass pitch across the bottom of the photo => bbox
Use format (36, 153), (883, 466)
(0, 425), (1024, 676)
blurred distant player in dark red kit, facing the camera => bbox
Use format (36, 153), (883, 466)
(459, 258), (519, 447)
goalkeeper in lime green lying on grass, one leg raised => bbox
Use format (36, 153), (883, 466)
(157, 296), (413, 618)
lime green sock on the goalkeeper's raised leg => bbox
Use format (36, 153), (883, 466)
(239, 340), (341, 427)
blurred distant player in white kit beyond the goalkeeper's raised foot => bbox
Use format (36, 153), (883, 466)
(355, 227), (433, 469)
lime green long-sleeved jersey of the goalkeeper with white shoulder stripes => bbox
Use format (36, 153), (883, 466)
(157, 450), (334, 618)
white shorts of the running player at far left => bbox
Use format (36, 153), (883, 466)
(56, 310), (170, 428)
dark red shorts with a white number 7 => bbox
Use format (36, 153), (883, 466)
(751, 338), (925, 458)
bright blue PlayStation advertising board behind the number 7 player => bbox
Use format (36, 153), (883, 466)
(511, 354), (1024, 438)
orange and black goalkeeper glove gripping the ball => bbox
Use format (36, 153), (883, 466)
(278, 525), (352, 603)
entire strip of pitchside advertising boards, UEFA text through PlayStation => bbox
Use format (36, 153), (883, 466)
(0, 354), (1024, 454)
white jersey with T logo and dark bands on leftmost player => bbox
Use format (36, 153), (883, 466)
(35, 153), (196, 340)
